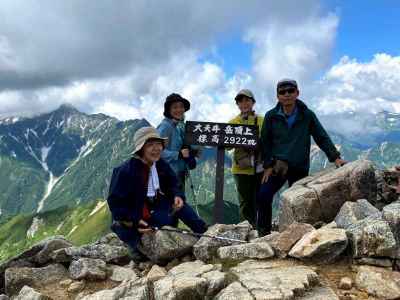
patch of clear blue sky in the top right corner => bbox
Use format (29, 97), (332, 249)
(328, 0), (400, 62)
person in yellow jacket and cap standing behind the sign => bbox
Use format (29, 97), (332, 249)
(229, 89), (264, 226)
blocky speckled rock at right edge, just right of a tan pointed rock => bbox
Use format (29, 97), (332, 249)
(346, 217), (396, 258)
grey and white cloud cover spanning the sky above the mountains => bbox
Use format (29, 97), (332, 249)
(0, 0), (400, 133)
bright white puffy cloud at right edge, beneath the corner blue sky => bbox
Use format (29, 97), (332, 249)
(313, 54), (400, 114)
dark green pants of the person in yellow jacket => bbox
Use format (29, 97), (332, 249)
(233, 173), (263, 228)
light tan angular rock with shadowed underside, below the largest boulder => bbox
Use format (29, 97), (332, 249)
(289, 228), (348, 263)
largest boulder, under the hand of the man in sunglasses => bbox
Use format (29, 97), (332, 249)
(279, 160), (376, 231)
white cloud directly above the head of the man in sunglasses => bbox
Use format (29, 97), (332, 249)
(246, 14), (339, 87)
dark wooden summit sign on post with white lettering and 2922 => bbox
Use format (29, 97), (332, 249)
(185, 121), (258, 223)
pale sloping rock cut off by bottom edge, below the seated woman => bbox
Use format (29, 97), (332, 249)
(81, 279), (151, 300)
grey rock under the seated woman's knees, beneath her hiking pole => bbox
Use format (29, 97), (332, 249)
(138, 226), (198, 263)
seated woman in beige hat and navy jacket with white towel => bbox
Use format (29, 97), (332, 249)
(107, 127), (207, 261)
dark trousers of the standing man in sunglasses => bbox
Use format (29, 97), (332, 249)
(257, 168), (308, 235)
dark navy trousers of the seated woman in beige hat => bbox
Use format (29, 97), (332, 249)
(111, 198), (207, 251)
